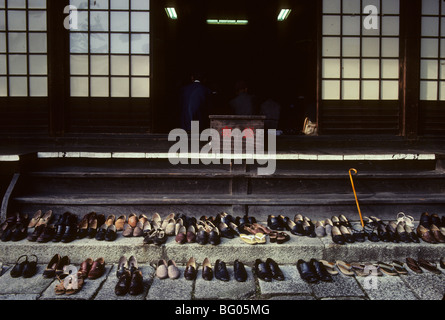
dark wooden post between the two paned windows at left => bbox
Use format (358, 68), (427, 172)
(48, 0), (69, 136)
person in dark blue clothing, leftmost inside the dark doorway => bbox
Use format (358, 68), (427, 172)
(180, 72), (211, 131)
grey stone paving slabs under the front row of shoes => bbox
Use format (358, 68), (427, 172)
(0, 258), (445, 304)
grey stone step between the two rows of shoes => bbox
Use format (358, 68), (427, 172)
(0, 225), (445, 265)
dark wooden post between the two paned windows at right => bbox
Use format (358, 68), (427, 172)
(400, 0), (422, 139)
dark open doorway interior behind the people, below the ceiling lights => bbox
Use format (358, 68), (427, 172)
(153, 0), (317, 132)
